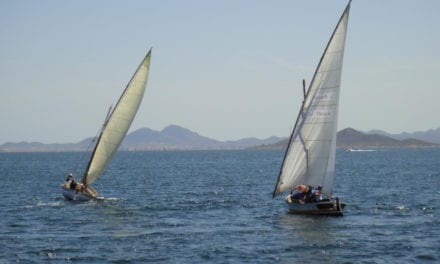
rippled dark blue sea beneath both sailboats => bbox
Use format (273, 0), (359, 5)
(0, 148), (440, 263)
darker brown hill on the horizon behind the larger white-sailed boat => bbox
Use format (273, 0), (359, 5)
(249, 128), (440, 149)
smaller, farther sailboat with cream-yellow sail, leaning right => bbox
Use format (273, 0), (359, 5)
(61, 49), (151, 201)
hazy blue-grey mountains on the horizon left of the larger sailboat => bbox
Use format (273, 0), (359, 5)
(0, 125), (282, 152)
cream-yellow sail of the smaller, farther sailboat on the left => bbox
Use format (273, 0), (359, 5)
(81, 50), (151, 184)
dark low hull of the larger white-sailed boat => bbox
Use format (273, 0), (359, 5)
(285, 197), (345, 216)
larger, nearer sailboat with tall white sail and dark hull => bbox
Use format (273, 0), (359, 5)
(273, 1), (351, 215)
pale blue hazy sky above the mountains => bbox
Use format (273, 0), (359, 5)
(0, 0), (440, 144)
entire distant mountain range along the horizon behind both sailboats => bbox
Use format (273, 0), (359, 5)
(0, 125), (440, 152)
